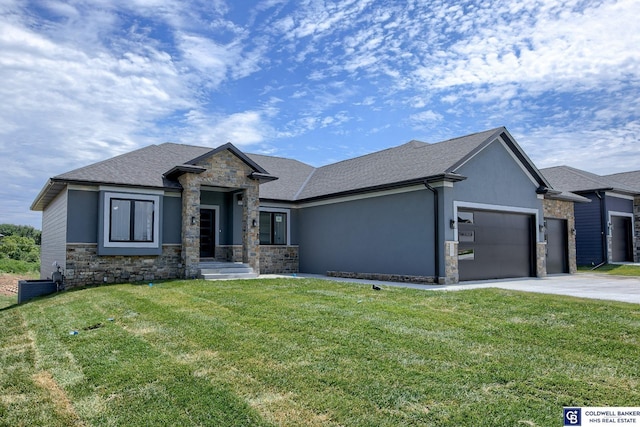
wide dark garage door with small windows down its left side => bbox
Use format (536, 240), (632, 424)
(458, 210), (535, 280)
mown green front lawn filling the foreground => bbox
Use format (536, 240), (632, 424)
(0, 279), (640, 426)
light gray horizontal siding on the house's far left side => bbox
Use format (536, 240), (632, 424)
(40, 189), (67, 279)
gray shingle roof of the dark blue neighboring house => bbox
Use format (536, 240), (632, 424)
(540, 166), (636, 194)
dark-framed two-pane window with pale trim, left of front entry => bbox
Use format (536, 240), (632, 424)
(109, 198), (154, 242)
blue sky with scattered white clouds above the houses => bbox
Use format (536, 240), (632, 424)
(0, 0), (640, 228)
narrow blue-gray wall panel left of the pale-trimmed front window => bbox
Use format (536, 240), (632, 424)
(67, 190), (99, 243)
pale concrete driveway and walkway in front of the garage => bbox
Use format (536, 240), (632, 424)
(298, 273), (640, 304)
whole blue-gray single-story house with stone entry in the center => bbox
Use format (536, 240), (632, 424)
(31, 128), (584, 286)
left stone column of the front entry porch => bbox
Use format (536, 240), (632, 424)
(178, 174), (200, 279)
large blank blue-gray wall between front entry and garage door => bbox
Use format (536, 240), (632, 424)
(297, 189), (435, 276)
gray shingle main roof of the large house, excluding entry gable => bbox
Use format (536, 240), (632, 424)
(32, 127), (547, 209)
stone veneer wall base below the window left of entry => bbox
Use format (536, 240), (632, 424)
(64, 243), (184, 288)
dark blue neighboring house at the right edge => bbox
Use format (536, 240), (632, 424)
(541, 166), (640, 266)
